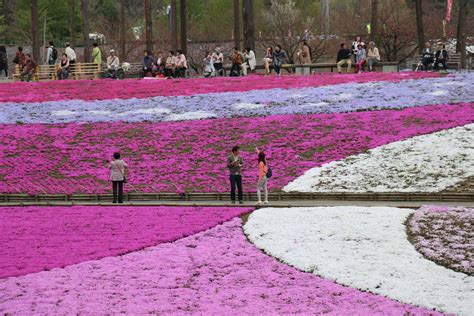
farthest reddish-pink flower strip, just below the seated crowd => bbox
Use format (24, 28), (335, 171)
(0, 72), (439, 102)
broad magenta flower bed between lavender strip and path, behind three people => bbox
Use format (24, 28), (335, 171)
(0, 104), (474, 194)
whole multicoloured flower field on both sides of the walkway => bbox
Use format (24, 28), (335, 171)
(0, 72), (474, 315)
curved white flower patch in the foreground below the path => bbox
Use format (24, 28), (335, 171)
(244, 206), (474, 315)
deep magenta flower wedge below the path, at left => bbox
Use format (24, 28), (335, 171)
(0, 206), (251, 278)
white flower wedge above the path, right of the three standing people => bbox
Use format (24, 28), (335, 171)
(283, 124), (474, 192)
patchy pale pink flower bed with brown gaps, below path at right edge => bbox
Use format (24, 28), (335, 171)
(407, 206), (474, 276)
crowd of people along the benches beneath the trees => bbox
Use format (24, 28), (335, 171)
(0, 36), (456, 81)
